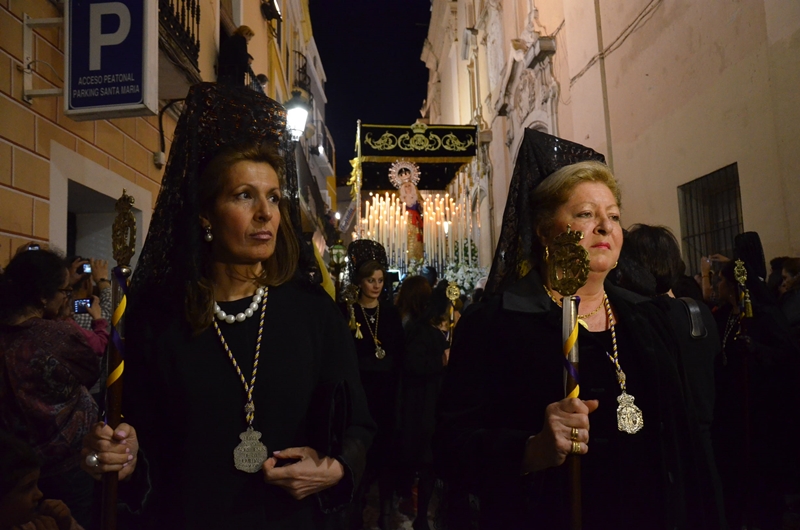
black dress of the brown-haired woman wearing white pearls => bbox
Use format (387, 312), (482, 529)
(123, 283), (375, 529)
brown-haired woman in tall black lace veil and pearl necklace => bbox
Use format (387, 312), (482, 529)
(84, 83), (375, 529)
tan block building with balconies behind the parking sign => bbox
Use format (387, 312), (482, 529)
(0, 0), (335, 265)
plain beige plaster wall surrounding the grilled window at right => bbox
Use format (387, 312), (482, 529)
(600, 0), (800, 258)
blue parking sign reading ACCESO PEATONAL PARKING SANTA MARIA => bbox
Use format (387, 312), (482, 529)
(64, 0), (158, 121)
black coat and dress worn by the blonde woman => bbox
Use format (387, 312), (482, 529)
(434, 272), (719, 530)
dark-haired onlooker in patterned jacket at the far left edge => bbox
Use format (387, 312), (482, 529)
(0, 246), (100, 526)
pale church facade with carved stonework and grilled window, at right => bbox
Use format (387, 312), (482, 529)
(421, 0), (800, 269)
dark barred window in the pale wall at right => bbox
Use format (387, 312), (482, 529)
(678, 163), (744, 274)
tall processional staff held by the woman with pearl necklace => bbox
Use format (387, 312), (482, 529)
(100, 190), (136, 530)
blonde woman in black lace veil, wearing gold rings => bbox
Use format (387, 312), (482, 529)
(434, 130), (722, 530)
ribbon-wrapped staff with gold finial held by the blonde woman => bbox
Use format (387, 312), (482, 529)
(547, 225), (589, 530)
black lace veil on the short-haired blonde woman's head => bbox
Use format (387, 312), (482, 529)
(485, 129), (605, 295)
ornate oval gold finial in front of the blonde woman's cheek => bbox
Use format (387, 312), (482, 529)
(547, 225), (589, 296)
